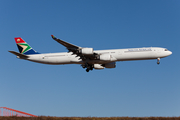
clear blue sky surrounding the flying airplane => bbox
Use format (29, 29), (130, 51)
(0, 0), (180, 117)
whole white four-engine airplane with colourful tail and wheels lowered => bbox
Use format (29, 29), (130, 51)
(9, 35), (172, 72)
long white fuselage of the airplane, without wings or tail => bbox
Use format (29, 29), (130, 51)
(26, 47), (172, 65)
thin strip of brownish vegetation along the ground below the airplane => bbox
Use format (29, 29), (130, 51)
(0, 116), (180, 120)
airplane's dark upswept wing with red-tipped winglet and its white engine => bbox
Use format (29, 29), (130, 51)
(51, 35), (98, 60)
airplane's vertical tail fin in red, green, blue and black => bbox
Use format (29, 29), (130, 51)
(14, 37), (39, 55)
